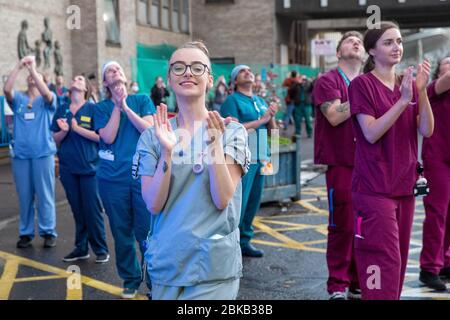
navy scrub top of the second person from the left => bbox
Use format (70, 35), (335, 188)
(51, 100), (99, 175)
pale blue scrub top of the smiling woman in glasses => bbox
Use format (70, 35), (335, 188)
(134, 119), (250, 286)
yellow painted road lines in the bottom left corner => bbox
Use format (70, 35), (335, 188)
(0, 251), (147, 300)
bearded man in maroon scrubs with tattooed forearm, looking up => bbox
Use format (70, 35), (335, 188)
(313, 31), (365, 300)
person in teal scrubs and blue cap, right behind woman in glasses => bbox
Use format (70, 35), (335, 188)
(220, 65), (277, 258)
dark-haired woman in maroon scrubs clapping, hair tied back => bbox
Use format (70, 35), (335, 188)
(349, 22), (434, 300)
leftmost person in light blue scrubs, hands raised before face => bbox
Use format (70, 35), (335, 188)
(4, 56), (57, 249)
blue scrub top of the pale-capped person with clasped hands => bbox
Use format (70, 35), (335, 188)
(94, 94), (156, 182)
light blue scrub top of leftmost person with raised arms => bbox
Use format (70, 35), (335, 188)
(8, 92), (57, 160)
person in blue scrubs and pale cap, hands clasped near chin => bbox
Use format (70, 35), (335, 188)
(94, 61), (156, 299)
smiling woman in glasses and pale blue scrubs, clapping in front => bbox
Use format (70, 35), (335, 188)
(134, 42), (250, 300)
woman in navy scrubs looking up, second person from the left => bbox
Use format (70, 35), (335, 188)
(51, 76), (109, 263)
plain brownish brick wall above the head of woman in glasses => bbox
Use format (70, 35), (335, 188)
(192, 0), (277, 64)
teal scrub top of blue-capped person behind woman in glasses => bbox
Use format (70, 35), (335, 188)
(220, 91), (269, 163)
